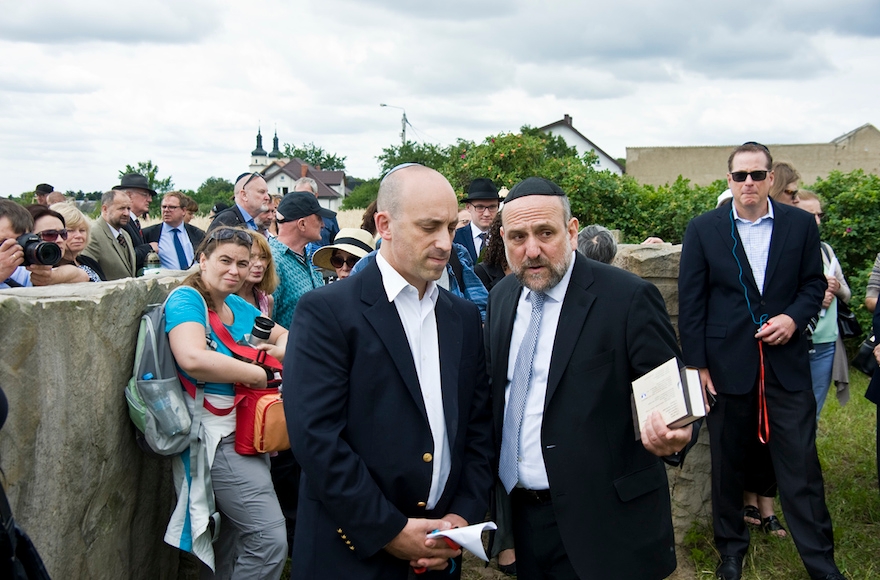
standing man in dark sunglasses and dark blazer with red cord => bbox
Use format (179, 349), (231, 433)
(678, 142), (844, 580)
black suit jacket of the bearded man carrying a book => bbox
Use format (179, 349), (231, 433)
(486, 252), (679, 580)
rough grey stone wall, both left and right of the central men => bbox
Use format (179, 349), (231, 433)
(0, 244), (709, 580)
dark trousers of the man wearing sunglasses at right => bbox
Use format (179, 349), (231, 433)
(708, 368), (838, 578)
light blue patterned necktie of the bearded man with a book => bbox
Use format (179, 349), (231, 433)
(498, 292), (547, 493)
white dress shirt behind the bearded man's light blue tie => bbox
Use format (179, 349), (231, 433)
(504, 252), (575, 489)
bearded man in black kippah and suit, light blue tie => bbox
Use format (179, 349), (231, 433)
(485, 177), (695, 580)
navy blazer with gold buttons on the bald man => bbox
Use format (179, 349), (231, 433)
(284, 262), (493, 580)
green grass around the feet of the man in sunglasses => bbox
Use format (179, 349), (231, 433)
(685, 369), (880, 580)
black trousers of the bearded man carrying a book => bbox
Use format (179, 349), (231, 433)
(510, 489), (578, 580)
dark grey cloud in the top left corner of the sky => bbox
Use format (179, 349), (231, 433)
(0, 0), (220, 44)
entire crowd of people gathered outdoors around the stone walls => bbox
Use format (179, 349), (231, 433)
(0, 143), (868, 580)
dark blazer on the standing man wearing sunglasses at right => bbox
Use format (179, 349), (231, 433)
(678, 201), (828, 394)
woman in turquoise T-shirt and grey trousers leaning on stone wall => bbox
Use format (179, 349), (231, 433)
(165, 227), (287, 578)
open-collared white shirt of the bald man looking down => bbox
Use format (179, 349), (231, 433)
(376, 252), (451, 510)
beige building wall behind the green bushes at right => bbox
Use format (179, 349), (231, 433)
(626, 124), (880, 185)
